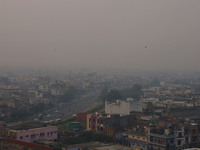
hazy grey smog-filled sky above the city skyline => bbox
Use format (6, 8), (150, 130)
(0, 0), (200, 70)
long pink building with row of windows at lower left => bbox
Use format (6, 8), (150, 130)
(8, 126), (57, 143)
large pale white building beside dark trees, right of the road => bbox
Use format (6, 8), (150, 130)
(105, 98), (143, 115)
